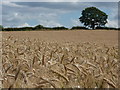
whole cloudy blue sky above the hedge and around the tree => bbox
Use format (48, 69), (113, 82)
(0, 0), (118, 28)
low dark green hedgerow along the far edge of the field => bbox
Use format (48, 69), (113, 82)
(0, 25), (120, 31)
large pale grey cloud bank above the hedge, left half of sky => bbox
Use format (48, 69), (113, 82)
(2, 3), (63, 27)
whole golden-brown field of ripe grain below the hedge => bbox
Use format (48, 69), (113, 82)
(0, 30), (119, 88)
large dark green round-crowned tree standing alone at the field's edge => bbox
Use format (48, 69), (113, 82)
(79, 7), (108, 29)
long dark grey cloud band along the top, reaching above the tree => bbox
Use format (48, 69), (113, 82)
(14, 0), (117, 10)
